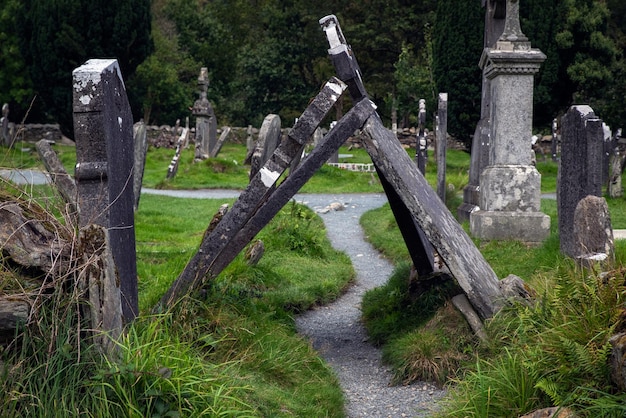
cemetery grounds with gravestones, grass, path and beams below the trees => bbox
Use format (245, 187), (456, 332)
(0, 0), (626, 417)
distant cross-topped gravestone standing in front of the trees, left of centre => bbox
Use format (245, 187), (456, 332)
(191, 67), (217, 160)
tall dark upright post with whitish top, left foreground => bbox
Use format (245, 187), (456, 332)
(72, 59), (139, 331)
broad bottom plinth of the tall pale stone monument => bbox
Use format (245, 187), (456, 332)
(470, 210), (550, 244)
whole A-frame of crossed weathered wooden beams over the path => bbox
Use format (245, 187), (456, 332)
(155, 15), (503, 318)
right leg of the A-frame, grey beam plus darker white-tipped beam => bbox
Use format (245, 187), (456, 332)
(320, 15), (503, 318)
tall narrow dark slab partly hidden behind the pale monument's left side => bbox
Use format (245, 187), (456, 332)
(457, 0), (506, 221)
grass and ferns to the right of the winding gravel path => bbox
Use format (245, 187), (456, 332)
(361, 158), (626, 418)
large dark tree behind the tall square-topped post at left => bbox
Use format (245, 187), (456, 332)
(18, 0), (152, 135)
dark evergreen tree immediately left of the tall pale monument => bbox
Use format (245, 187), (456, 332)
(433, 0), (484, 145)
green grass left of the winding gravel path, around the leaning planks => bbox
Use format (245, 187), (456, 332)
(0, 176), (354, 417)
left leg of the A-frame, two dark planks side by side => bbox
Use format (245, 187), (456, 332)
(154, 78), (374, 312)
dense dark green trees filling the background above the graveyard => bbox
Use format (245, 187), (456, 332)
(0, 0), (626, 139)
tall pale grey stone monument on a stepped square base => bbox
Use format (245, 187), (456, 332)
(470, 0), (550, 243)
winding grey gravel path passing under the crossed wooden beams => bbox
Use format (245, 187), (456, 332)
(296, 194), (444, 418)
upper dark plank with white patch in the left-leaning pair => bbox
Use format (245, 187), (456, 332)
(156, 77), (346, 310)
